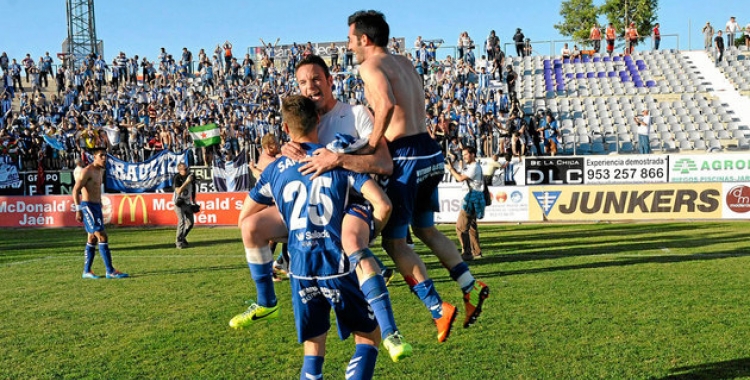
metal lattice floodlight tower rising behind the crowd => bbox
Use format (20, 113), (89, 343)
(64, 0), (102, 65)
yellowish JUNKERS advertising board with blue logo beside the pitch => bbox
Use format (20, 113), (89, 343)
(529, 183), (724, 221)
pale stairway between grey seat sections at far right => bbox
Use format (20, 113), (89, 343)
(682, 50), (750, 132)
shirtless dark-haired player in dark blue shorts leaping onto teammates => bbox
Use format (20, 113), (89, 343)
(348, 11), (489, 342)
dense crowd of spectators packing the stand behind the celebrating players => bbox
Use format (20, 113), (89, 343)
(0, 31), (568, 170)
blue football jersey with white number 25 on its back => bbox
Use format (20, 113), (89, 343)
(250, 143), (370, 278)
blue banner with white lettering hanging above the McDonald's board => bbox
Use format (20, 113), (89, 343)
(105, 150), (187, 193)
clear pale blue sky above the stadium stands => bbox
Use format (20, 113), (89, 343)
(0, 0), (750, 59)
